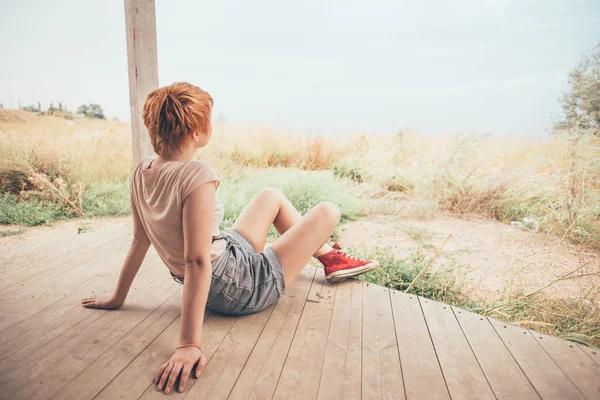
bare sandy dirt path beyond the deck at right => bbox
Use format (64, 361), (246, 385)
(340, 215), (600, 300)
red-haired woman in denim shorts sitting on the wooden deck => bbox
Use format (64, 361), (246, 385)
(82, 83), (377, 393)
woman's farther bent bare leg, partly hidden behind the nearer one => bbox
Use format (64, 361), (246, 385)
(233, 188), (333, 259)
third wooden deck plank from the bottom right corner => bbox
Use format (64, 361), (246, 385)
(452, 307), (540, 400)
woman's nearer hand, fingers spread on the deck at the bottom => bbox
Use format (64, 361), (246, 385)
(154, 347), (206, 394)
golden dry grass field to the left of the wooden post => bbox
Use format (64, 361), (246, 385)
(0, 110), (132, 185)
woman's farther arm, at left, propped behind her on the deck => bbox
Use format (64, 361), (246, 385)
(81, 198), (150, 310)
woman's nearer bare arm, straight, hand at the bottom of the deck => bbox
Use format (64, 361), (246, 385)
(155, 182), (216, 393)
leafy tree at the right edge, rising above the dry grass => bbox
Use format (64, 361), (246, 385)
(554, 42), (600, 135)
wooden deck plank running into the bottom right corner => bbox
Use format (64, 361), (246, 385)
(529, 331), (600, 399)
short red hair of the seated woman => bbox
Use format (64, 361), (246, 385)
(142, 82), (213, 155)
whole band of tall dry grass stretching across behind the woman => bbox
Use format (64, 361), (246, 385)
(0, 110), (600, 247)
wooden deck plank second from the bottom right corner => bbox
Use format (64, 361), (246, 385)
(488, 318), (584, 399)
